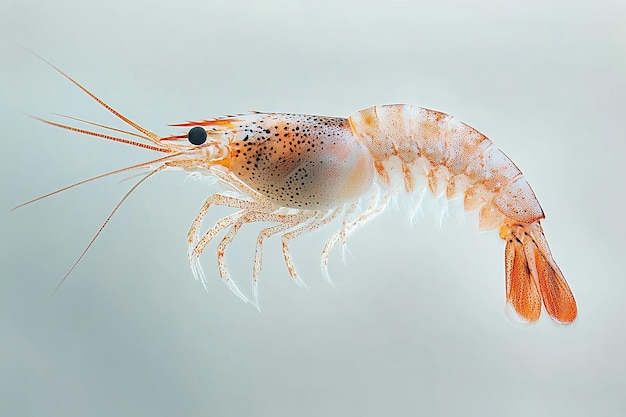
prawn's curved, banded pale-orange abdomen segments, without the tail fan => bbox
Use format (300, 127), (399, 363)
(348, 105), (544, 229)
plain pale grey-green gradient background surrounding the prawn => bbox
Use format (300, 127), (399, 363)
(0, 0), (626, 416)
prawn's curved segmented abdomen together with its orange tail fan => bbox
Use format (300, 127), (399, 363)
(348, 105), (577, 323)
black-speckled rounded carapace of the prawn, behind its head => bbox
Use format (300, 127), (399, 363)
(223, 114), (374, 209)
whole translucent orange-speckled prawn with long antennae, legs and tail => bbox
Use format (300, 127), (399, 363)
(14, 58), (577, 324)
